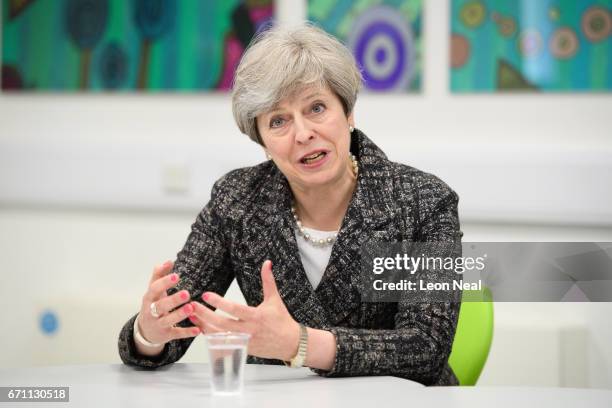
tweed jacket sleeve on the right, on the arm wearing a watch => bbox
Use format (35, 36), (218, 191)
(314, 176), (462, 385)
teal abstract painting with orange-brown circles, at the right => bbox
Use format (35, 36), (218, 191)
(450, 0), (612, 93)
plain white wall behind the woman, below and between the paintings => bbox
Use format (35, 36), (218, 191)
(0, 0), (612, 388)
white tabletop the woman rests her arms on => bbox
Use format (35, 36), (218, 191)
(0, 363), (612, 408)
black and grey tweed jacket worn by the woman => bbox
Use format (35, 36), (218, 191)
(119, 130), (462, 385)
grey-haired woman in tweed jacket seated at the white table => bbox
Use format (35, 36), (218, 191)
(119, 25), (462, 385)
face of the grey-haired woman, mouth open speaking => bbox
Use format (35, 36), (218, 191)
(257, 87), (354, 190)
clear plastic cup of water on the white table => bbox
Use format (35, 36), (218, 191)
(204, 332), (251, 395)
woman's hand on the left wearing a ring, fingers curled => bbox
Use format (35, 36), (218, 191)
(136, 261), (200, 354)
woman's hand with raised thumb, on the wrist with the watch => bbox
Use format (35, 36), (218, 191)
(189, 260), (300, 361)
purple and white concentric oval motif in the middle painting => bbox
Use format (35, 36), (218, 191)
(348, 6), (414, 91)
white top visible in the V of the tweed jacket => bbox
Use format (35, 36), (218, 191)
(295, 227), (338, 289)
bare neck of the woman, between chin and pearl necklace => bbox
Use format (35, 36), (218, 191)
(291, 173), (357, 231)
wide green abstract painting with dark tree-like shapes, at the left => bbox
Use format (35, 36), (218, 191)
(2, 0), (274, 91)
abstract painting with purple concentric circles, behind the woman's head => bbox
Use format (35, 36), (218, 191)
(308, 0), (423, 92)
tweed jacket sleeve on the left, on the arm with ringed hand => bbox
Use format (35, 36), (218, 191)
(119, 179), (234, 368)
